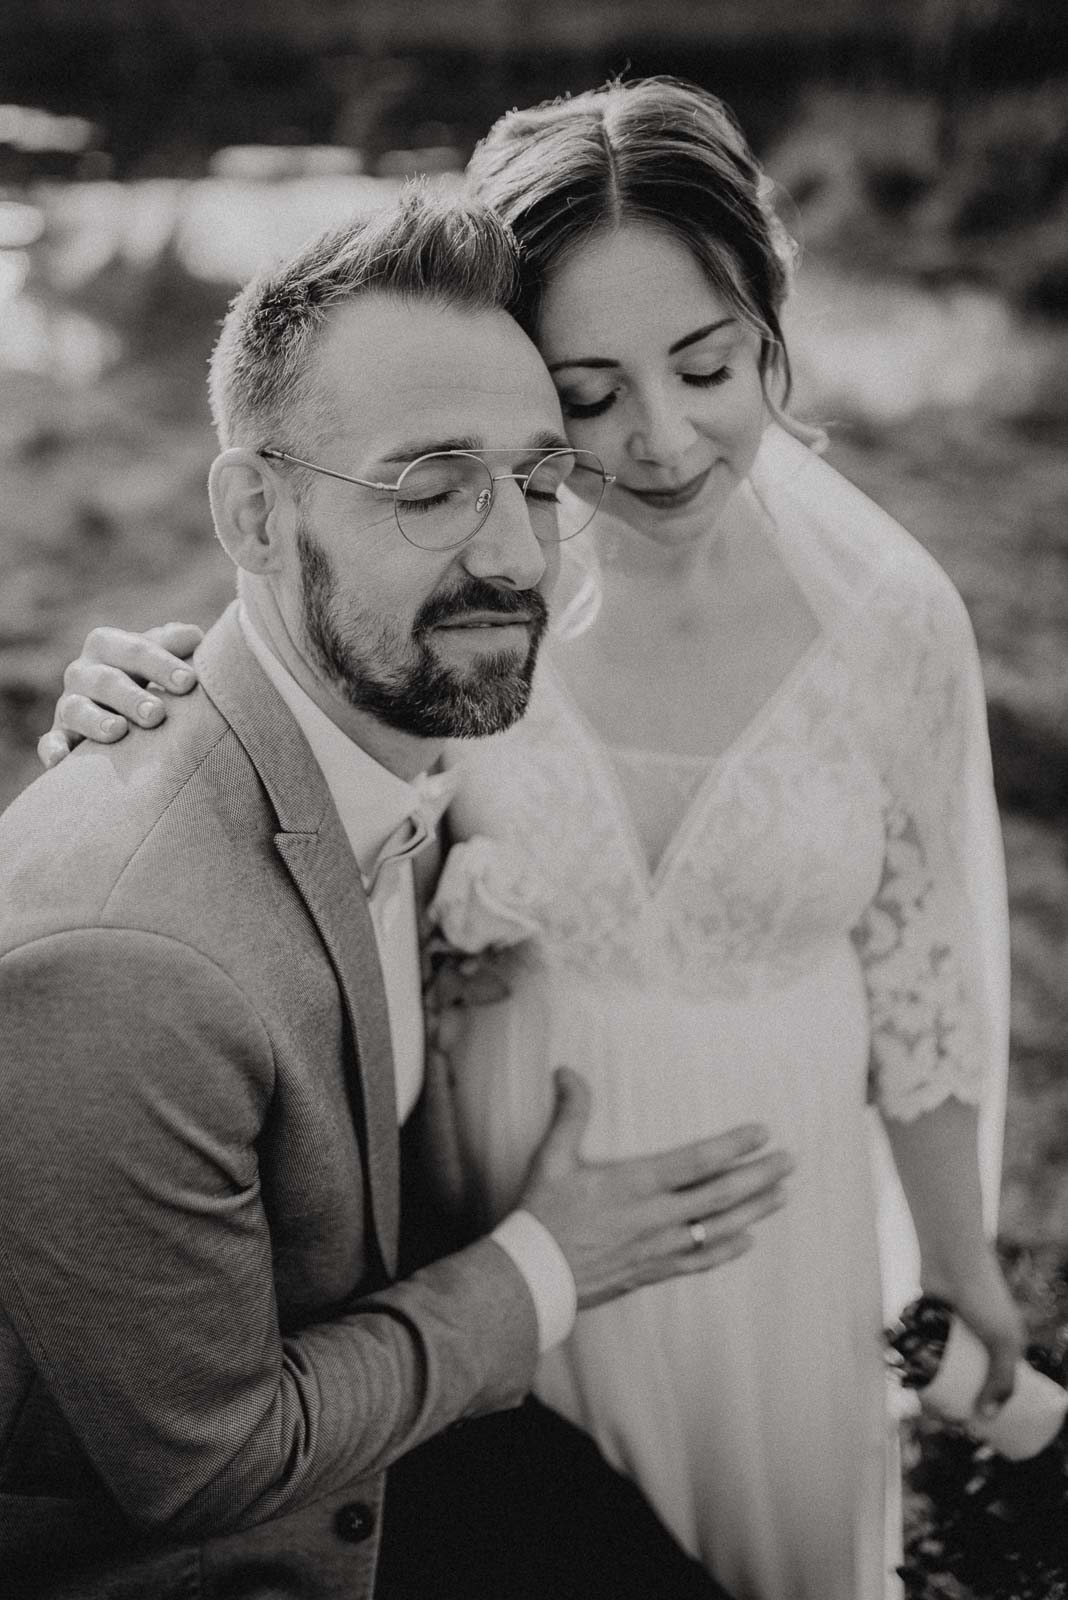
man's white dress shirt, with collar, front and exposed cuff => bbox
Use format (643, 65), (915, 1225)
(238, 606), (577, 1352)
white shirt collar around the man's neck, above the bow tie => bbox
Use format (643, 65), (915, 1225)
(238, 605), (441, 882)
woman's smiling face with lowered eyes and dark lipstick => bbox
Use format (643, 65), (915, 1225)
(539, 222), (766, 544)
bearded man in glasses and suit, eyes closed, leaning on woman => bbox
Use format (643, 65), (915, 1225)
(0, 194), (783, 1600)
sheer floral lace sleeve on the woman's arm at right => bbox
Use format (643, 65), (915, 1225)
(855, 558), (1009, 1210)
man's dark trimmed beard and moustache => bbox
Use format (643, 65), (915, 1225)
(297, 528), (548, 739)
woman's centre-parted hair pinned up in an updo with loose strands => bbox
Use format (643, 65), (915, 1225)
(467, 78), (795, 408)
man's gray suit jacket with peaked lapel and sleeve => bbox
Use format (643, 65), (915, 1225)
(0, 610), (537, 1600)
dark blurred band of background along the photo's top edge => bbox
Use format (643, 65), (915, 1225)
(0, 0), (1068, 181)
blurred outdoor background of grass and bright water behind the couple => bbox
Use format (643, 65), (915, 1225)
(0, 0), (1068, 1600)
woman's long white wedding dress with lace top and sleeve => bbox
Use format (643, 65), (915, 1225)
(435, 430), (1006, 1600)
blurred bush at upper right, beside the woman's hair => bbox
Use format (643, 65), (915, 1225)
(769, 77), (1068, 320)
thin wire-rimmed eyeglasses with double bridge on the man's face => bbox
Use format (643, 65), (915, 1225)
(259, 448), (616, 550)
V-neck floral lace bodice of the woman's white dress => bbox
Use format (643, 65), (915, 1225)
(441, 650), (883, 998)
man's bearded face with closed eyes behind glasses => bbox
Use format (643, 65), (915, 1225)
(278, 294), (566, 739)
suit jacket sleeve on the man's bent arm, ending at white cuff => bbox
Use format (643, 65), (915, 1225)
(0, 928), (537, 1538)
